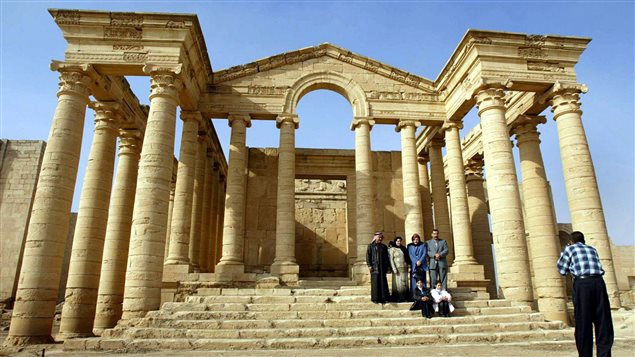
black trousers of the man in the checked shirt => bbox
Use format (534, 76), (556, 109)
(573, 276), (613, 357)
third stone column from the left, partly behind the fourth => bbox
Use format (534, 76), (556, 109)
(93, 130), (141, 335)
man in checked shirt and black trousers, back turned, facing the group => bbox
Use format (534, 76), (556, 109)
(557, 231), (613, 357)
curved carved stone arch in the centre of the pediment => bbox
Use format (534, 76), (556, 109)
(283, 71), (369, 117)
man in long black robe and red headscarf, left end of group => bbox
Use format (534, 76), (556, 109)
(366, 232), (390, 304)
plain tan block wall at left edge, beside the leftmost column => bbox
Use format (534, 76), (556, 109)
(0, 139), (46, 300)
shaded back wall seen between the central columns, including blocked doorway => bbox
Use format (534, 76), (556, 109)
(244, 148), (409, 276)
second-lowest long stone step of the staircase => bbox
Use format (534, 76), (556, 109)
(104, 320), (565, 339)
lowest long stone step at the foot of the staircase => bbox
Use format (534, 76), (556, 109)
(64, 328), (572, 352)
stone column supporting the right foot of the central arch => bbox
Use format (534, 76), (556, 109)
(351, 117), (375, 283)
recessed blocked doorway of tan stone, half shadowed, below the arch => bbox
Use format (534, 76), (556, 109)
(295, 178), (349, 277)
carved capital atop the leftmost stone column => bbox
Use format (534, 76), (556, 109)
(49, 61), (97, 99)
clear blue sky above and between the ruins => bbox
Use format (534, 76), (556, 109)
(0, 0), (635, 245)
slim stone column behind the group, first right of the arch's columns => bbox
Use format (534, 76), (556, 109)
(395, 120), (425, 240)
